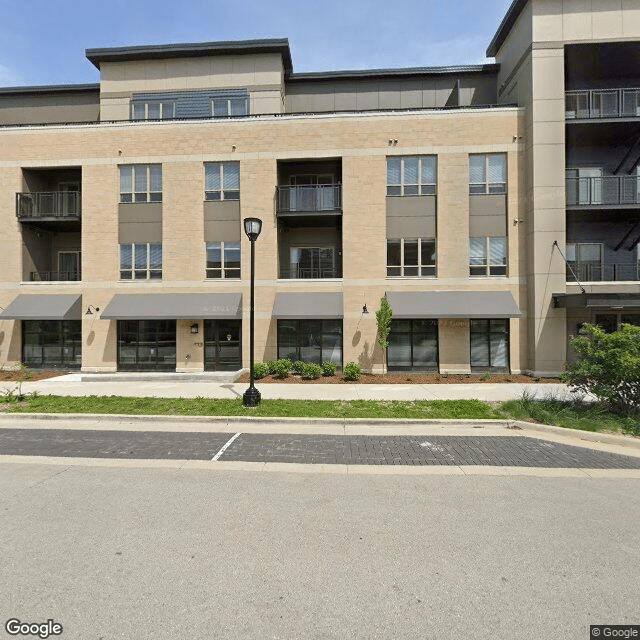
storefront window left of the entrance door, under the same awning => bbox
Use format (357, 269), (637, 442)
(118, 320), (176, 371)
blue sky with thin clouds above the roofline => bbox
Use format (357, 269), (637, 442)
(0, 0), (511, 87)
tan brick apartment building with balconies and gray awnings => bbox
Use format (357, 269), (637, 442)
(0, 0), (640, 375)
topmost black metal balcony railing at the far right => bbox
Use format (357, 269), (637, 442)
(565, 88), (640, 120)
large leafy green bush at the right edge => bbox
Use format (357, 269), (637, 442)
(562, 324), (640, 415)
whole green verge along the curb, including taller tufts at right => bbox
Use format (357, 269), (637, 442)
(0, 396), (640, 436)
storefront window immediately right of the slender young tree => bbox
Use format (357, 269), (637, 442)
(387, 320), (438, 371)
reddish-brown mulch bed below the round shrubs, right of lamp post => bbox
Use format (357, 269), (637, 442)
(236, 373), (560, 384)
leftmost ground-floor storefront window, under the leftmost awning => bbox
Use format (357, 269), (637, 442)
(22, 320), (82, 369)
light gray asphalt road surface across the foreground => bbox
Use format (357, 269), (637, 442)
(0, 462), (640, 640)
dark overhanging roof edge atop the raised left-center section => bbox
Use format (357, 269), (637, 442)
(85, 38), (293, 73)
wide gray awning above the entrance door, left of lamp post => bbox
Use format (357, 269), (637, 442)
(100, 293), (242, 320)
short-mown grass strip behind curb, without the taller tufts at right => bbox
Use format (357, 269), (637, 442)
(3, 396), (504, 419)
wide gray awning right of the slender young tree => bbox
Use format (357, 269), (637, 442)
(387, 291), (522, 318)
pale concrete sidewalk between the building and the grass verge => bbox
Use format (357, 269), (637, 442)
(10, 373), (588, 402)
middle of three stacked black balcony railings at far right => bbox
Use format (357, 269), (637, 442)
(567, 176), (640, 206)
